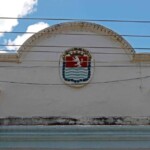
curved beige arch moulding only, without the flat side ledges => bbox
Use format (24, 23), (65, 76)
(18, 22), (135, 59)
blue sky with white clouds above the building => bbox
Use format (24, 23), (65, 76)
(0, 0), (150, 52)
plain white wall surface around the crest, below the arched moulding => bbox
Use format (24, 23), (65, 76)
(0, 30), (150, 117)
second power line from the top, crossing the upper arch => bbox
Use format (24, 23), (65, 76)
(0, 31), (150, 38)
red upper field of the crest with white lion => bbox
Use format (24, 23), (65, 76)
(65, 55), (89, 67)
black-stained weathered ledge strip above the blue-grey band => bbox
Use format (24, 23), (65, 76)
(0, 116), (150, 126)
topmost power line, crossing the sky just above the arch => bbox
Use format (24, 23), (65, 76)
(0, 17), (150, 23)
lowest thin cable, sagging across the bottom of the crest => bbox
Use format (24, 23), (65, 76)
(0, 76), (150, 86)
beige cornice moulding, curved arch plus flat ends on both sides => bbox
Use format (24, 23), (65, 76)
(0, 22), (150, 62)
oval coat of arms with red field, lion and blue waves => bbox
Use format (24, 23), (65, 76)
(60, 48), (94, 87)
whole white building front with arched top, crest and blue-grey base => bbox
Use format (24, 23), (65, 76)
(0, 22), (150, 150)
